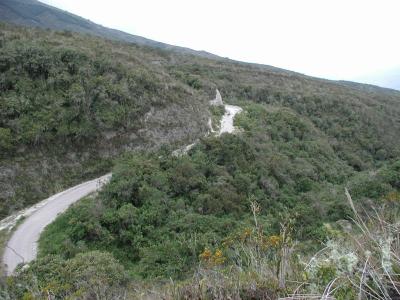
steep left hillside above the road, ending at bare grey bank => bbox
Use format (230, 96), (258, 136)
(0, 22), (214, 217)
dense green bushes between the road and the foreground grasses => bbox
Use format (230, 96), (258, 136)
(36, 104), (398, 278)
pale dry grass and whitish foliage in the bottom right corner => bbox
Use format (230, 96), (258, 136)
(300, 191), (400, 299)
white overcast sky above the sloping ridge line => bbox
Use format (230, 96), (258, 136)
(41, 0), (400, 88)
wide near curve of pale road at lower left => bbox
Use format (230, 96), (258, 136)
(3, 174), (111, 275)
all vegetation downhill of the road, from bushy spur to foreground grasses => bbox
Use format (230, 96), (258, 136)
(1, 104), (400, 299)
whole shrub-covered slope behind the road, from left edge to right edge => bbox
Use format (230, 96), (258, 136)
(0, 21), (400, 220)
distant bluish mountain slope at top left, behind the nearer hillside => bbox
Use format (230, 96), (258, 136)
(0, 0), (219, 59)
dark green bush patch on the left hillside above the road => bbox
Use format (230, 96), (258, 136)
(0, 41), (162, 148)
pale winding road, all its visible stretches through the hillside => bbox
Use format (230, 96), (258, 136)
(0, 104), (242, 275)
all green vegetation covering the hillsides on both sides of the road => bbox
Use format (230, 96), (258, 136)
(0, 25), (400, 299)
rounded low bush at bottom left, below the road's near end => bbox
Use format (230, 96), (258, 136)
(2, 251), (127, 299)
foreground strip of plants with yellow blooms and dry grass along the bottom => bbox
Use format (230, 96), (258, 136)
(1, 186), (400, 300)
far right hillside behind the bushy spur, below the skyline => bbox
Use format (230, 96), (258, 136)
(173, 59), (400, 170)
